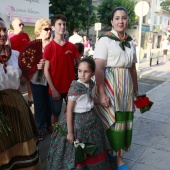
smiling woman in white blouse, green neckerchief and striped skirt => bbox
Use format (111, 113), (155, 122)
(93, 7), (138, 170)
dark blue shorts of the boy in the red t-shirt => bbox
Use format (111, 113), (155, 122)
(50, 93), (67, 117)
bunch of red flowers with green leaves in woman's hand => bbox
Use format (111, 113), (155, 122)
(134, 94), (153, 113)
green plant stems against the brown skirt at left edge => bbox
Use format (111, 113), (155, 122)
(0, 112), (11, 136)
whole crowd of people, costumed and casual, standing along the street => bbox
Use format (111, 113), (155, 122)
(0, 7), (141, 170)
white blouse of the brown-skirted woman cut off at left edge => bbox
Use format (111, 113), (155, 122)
(0, 50), (21, 90)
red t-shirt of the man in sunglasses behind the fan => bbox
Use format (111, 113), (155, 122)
(9, 32), (30, 52)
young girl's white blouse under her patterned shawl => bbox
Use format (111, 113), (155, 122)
(68, 80), (95, 113)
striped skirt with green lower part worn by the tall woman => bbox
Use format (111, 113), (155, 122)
(95, 68), (134, 155)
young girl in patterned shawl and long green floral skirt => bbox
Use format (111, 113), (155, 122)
(47, 57), (110, 170)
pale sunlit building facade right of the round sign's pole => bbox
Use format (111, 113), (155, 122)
(139, 0), (170, 48)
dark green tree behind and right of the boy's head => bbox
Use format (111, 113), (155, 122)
(49, 0), (96, 35)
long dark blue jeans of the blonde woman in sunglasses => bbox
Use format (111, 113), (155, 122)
(31, 83), (52, 133)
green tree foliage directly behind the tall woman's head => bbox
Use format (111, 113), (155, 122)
(97, 0), (136, 28)
